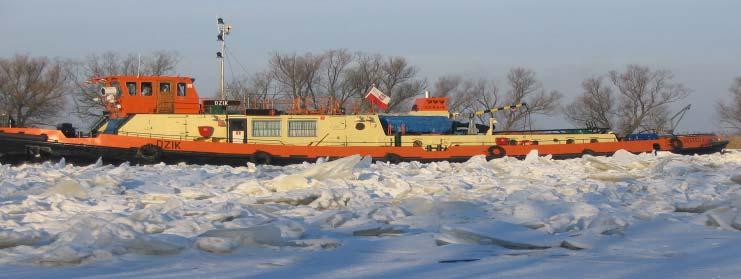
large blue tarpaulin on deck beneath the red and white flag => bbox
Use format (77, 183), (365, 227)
(378, 115), (453, 134)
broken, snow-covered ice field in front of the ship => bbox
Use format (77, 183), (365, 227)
(0, 151), (741, 278)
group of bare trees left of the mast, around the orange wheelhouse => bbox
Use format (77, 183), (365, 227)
(0, 51), (180, 126)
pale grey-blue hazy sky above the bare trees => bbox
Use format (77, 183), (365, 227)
(0, 0), (741, 131)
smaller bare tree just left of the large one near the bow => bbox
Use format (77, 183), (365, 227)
(564, 77), (617, 128)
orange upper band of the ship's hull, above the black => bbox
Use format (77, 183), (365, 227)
(0, 128), (725, 163)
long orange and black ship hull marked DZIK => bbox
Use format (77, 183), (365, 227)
(0, 128), (728, 165)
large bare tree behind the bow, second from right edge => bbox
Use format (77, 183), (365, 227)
(609, 65), (689, 134)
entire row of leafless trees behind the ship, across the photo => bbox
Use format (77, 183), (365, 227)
(0, 49), (741, 134)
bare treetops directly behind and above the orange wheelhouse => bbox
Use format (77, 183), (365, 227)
(73, 50), (180, 119)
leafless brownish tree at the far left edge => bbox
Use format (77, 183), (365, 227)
(0, 55), (71, 126)
